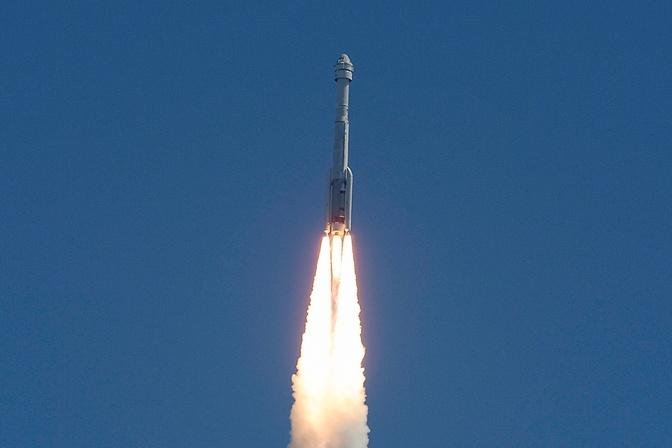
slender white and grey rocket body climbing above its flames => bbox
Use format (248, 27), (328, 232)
(324, 53), (355, 235)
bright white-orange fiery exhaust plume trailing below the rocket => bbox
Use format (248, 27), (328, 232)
(289, 235), (369, 448)
